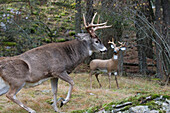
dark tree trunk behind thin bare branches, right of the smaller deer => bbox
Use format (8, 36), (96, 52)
(136, 0), (149, 75)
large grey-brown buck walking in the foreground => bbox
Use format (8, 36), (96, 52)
(0, 13), (111, 113)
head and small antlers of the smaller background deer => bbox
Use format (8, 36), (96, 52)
(108, 38), (126, 54)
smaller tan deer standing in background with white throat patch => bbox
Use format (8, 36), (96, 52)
(89, 38), (126, 88)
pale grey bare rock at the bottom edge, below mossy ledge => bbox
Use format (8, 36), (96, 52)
(129, 106), (150, 113)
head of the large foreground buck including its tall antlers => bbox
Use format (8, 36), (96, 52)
(78, 13), (111, 52)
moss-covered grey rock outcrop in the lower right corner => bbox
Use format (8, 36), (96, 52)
(83, 94), (170, 113)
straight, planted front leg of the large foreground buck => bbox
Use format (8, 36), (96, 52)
(50, 78), (58, 112)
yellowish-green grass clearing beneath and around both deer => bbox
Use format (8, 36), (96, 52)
(0, 73), (170, 113)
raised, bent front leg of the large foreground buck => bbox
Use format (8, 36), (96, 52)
(59, 72), (74, 104)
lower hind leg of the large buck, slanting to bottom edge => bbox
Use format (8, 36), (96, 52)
(6, 83), (36, 113)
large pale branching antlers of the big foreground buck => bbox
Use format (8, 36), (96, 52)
(83, 12), (112, 37)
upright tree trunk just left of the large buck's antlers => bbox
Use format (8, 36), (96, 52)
(75, 0), (81, 34)
